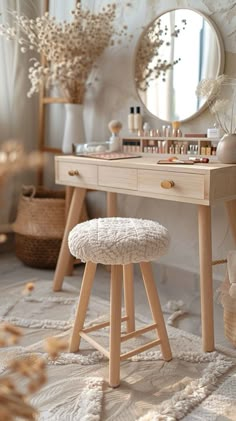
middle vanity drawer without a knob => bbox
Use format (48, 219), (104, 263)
(98, 167), (138, 190)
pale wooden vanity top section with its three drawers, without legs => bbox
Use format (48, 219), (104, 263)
(55, 155), (236, 205)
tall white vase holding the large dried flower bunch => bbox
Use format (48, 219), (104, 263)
(62, 104), (86, 154)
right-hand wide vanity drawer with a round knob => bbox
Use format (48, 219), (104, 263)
(138, 170), (204, 199)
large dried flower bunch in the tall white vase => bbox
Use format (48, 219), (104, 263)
(0, 3), (130, 104)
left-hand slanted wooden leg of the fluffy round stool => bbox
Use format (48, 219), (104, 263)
(69, 262), (97, 352)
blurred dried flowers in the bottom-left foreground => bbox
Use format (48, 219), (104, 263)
(0, 282), (68, 421)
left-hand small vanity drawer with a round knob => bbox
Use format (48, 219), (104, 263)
(56, 161), (97, 187)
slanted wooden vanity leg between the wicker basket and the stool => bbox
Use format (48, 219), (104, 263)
(53, 188), (86, 291)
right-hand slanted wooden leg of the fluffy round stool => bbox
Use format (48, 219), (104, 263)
(140, 262), (172, 361)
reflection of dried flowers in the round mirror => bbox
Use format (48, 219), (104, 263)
(135, 18), (187, 92)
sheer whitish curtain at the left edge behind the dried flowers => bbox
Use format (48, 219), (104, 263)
(0, 0), (43, 231)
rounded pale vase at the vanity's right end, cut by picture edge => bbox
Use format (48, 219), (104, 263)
(216, 133), (236, 164)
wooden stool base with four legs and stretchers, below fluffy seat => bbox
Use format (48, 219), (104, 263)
(69, 262), (172, 388)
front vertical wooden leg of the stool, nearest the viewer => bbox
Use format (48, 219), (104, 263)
(109, 265), (122, 387)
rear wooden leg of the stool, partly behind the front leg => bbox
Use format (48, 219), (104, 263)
(123, 263), (135, 333)
